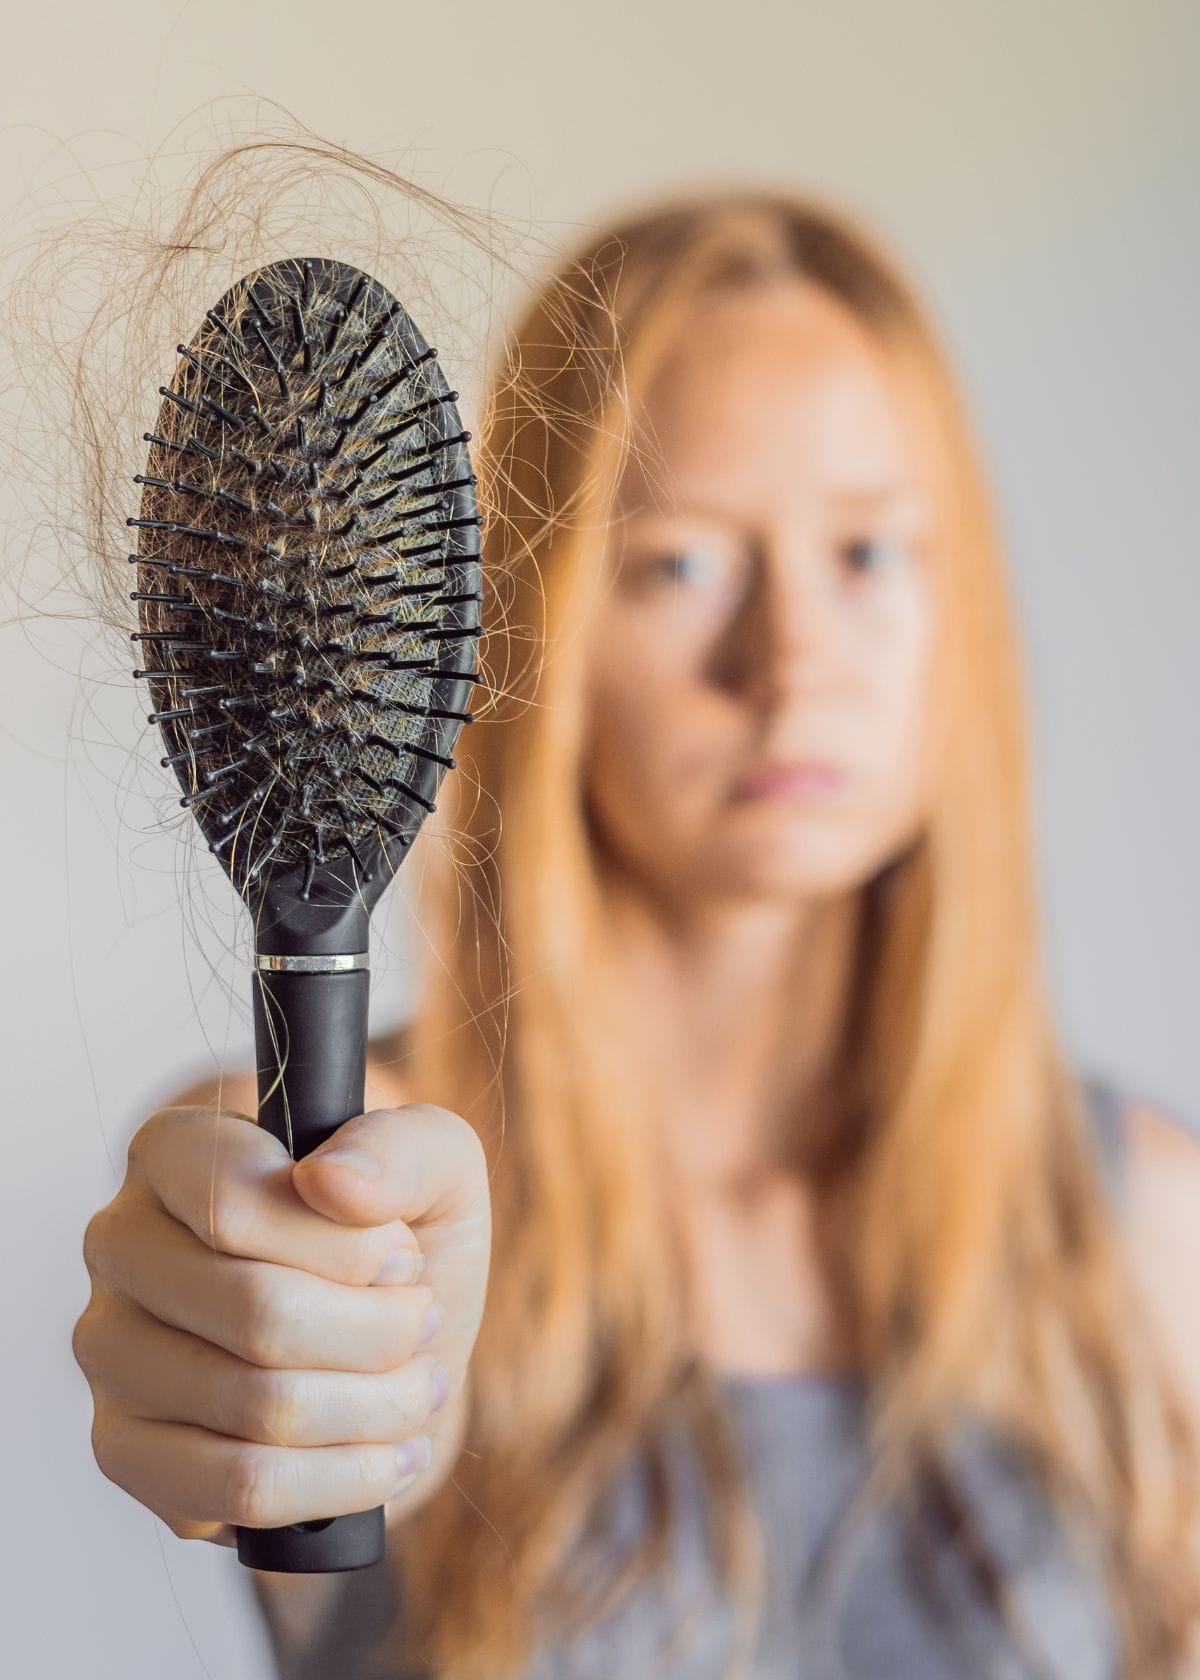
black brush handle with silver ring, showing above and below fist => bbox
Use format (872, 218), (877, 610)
(237, 956), (385, 1574)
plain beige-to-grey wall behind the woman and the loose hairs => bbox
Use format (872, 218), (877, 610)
(0, 0), (1200, 1680)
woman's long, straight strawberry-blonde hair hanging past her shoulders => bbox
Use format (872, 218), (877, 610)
(384, 192), (1197, 1680)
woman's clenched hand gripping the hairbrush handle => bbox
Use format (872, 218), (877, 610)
(72, 1104), (491, 1544)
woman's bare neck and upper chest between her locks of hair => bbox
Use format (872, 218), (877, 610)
(610, 892), (862, 1374)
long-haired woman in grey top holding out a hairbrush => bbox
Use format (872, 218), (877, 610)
(76, 192), (1200, 1680)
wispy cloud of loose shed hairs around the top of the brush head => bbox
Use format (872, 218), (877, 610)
(2, 101), (564, 664)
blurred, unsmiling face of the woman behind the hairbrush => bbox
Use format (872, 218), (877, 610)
(585, 284), (934, 902)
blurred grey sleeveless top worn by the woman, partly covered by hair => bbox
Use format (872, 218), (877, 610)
(252, 1079), (1123, 1680)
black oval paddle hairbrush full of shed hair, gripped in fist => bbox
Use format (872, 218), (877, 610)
(128, 259), (482, 1572)
